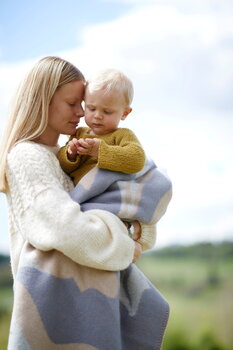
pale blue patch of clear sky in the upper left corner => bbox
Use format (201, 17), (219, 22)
(0, 0), (130, 62)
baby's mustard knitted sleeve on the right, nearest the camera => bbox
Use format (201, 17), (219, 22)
(97, 128), (145, 174)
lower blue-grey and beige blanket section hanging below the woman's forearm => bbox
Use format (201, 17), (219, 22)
(8, 243), (169, 350)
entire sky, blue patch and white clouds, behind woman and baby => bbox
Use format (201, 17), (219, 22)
(0, 0), (233, 251)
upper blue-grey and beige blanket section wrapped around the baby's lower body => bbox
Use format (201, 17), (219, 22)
(70, 158), (172, 224)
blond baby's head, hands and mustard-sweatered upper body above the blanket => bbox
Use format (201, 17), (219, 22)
(58, 69), (145, 185)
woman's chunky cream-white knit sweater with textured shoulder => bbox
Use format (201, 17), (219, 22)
(7, 141), (155, 276)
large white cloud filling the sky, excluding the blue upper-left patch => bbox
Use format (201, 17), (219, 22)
(0, 0), (233, 252)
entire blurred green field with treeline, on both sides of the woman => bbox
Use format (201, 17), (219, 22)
(0, 243), (233, 350)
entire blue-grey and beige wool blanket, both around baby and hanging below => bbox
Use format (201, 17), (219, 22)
(8, 160), (171, 350)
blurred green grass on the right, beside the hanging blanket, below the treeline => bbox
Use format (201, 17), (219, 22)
(138, 254), (233, 350)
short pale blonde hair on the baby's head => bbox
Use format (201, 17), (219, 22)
(87, 69), (134, 107)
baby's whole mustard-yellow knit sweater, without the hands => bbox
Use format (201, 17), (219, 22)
(58, 127), (145, 185)
